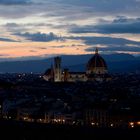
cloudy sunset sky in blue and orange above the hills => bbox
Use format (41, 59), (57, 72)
(0, 0), (140, 61)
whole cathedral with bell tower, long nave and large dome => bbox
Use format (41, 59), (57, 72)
(43, 48), (110, 82)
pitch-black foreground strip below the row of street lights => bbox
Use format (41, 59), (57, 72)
(0, 121), (140, 140)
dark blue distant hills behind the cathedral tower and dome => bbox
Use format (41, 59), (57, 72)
(0, 54), (140, 73)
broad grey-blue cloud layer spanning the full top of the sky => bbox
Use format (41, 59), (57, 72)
(0, 0), (140, 22)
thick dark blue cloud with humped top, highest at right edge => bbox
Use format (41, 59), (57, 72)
(70, 17), (140, 34)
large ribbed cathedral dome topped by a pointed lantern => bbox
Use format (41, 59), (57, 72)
(87, 48), (107, 74)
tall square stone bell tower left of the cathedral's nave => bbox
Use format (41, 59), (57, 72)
(54, 56), (61, 82)
